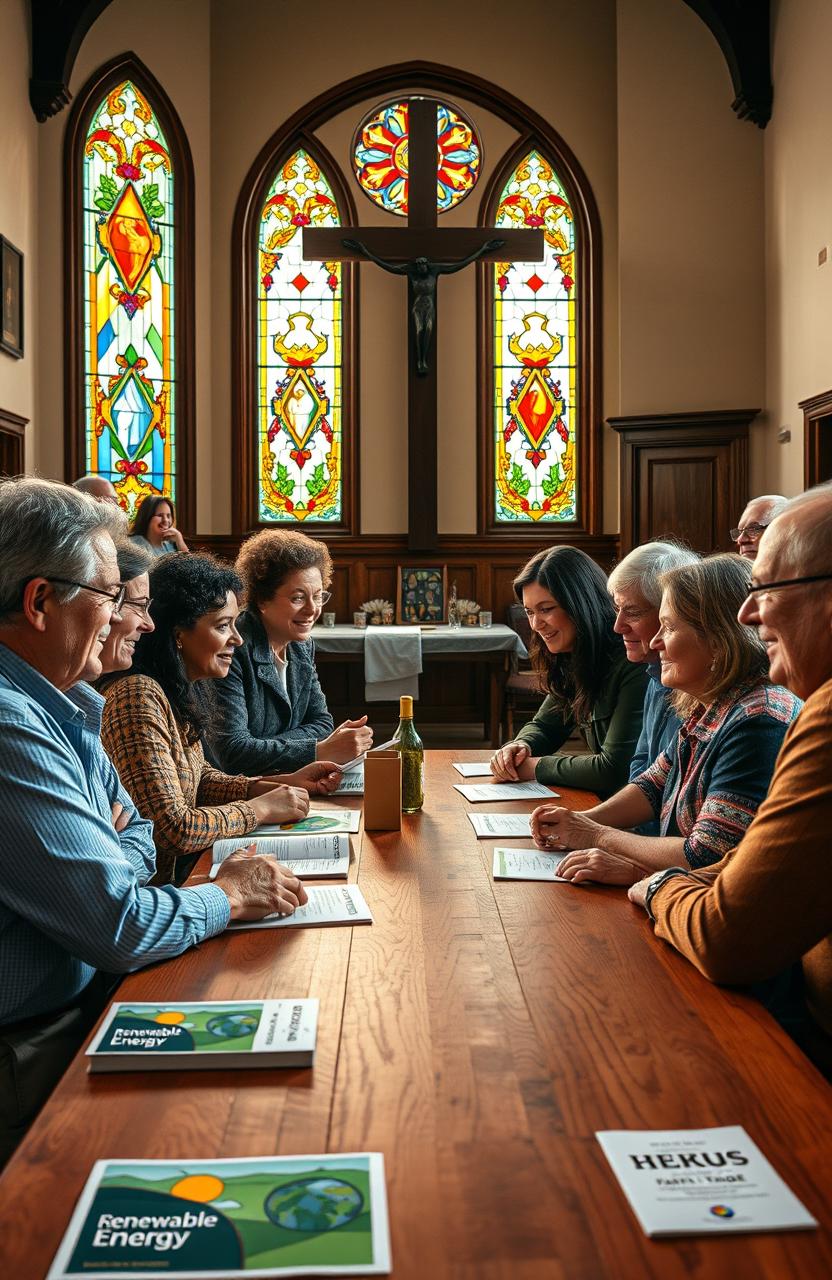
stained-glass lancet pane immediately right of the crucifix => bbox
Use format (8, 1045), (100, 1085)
(493, 151), (580, 525)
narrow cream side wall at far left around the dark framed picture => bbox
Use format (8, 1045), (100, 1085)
(0, 0), (38, 468)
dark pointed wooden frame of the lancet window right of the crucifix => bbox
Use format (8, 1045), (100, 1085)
(477, 137), (602, 543)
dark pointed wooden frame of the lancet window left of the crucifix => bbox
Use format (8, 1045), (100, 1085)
(232, 137), (358, 536)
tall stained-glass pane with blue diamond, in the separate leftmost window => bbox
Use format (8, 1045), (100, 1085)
(83, 81), (177, 515)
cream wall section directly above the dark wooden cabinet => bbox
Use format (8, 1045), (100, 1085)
(618, 0), (765, 427)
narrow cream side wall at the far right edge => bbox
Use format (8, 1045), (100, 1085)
(755, 0), (832, 494)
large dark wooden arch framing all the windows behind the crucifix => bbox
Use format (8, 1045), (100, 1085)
(232, 61), (602, 540)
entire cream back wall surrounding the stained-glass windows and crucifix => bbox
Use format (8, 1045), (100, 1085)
(19, 0), (773, 532)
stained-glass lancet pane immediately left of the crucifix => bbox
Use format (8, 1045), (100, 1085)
(257, 150), (343, 524)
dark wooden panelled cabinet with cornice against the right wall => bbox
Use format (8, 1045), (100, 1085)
(607, 408), (759, 556)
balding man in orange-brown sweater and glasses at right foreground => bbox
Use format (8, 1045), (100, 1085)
(630, 484), (832, 1049)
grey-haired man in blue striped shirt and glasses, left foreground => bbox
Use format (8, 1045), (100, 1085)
(0, 479), (306, 1165)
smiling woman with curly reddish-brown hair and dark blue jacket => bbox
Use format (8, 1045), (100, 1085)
(210, 529), (372, 773)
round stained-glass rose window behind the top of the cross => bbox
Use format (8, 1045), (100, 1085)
(352, 99), (483, 218)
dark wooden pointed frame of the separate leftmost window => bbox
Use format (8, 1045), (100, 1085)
(64, 52), (196, 532)
